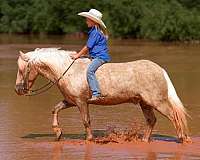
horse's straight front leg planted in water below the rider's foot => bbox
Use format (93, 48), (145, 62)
(77, 102), (93, 141)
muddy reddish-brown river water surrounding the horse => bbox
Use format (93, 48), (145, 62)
(0, 35), (200, 160)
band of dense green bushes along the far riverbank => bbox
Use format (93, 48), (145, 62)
(0, 0), (200, 41)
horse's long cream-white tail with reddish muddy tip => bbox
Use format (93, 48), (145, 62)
(163, 69), (189, 136)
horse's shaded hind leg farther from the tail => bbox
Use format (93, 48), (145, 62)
(140, 102), (156, 142)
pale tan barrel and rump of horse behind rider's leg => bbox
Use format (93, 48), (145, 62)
(96, 60), (167, 103)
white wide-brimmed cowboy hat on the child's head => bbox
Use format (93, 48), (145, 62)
(78, 9), (106, 29)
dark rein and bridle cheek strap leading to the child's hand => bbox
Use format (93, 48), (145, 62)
(25, 60), (75, 96)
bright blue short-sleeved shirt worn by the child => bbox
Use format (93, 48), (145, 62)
(86, 26), (111, 62)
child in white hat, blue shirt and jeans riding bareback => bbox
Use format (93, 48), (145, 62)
(72, 9), (111, 103)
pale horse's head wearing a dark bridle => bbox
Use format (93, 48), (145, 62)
(15, 51), (38, 95)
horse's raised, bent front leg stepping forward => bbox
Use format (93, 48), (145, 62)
(52, 100), (73, 141)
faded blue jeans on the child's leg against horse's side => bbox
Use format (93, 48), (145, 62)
(87, 58), (105, 96)
